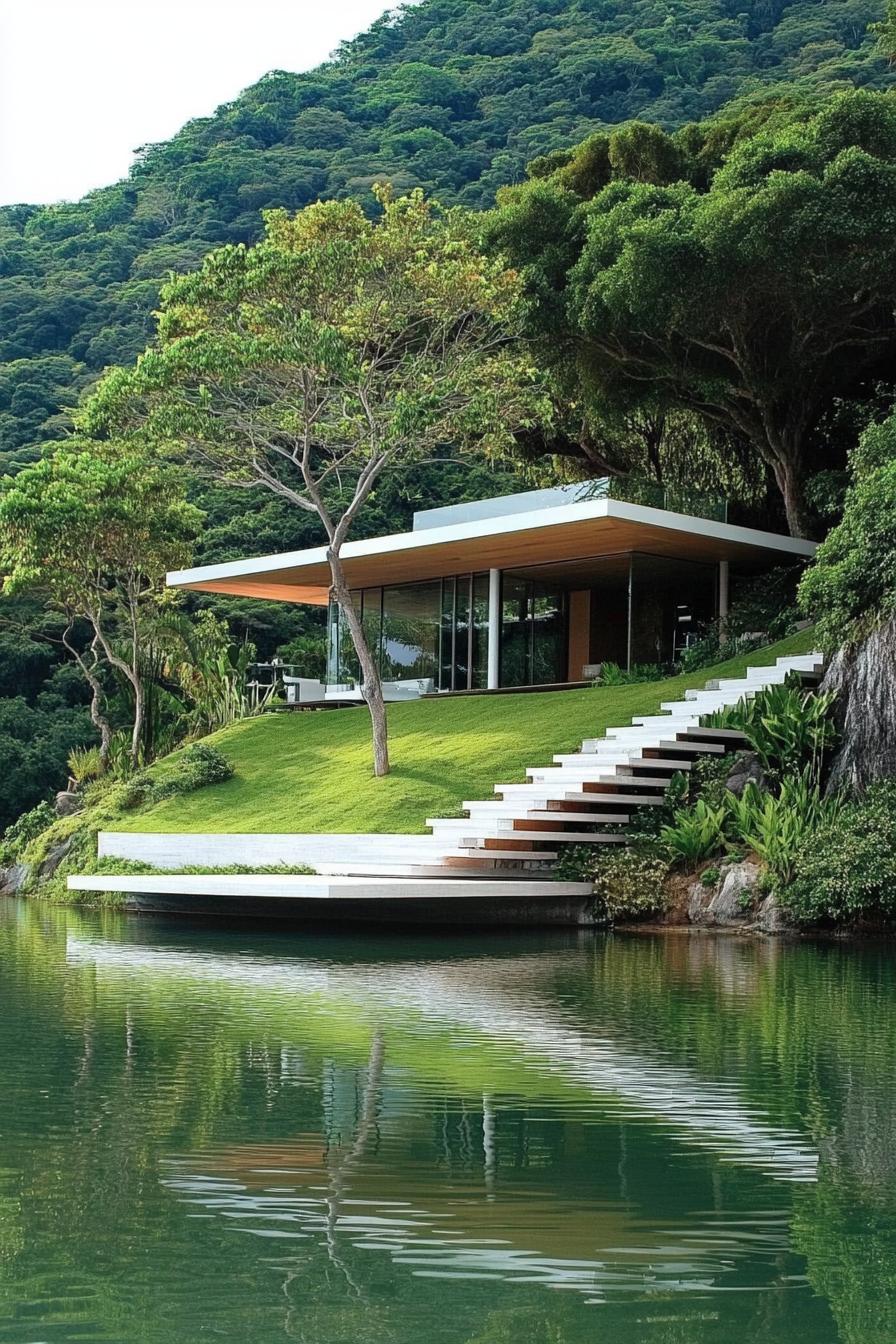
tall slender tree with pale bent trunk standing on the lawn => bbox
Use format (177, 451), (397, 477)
(79, 188), (549, 775)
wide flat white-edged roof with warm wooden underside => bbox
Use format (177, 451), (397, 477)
(168, 499), (815, 606)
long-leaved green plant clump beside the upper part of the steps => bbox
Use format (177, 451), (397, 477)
(725, 676), (837, 780)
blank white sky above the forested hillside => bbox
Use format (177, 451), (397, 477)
(0, 0), (390, 204)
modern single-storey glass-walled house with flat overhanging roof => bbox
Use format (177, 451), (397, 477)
(168, 480), (814, 694)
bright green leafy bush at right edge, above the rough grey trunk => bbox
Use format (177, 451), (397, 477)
(799, 403), (896, 649)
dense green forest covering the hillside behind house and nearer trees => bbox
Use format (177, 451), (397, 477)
(0, 0), (896, 825)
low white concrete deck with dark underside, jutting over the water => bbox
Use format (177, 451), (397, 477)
(69, 874), (595, 927)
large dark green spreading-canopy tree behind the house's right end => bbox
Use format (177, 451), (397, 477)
(493, 91), (896, 535)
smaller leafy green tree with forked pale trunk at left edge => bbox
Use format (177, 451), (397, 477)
(0, 439), (203, 766)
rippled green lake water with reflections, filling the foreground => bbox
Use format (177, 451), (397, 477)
(0, 902), (896, 1344)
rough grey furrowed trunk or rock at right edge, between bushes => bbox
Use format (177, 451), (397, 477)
(822, 617), (896, 792)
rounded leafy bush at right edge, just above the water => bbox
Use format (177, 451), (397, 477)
(779, 780), (896, 923)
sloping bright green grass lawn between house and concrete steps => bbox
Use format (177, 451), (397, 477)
(120, 630), (813, 833)
